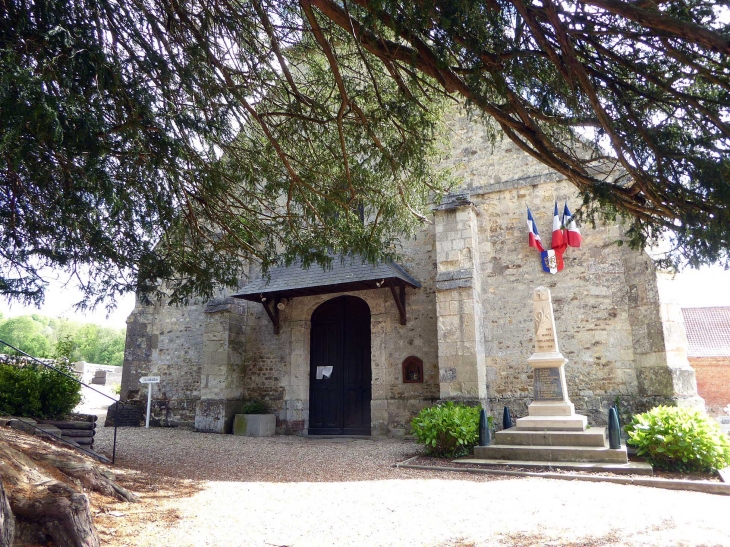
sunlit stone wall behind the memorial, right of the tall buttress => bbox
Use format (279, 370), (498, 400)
(436, 109), (702, 424)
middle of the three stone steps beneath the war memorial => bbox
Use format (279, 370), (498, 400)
(474, 445), (629, 463)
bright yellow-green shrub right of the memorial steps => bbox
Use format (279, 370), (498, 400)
(626, 406), (730, 471)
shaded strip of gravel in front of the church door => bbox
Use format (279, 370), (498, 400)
(96, 427), (508, 482)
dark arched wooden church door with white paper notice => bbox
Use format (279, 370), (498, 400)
(309, 296), (371, 435)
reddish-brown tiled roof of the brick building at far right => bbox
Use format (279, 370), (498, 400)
(682, 306), (730, 357)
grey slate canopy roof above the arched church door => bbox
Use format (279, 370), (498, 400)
(232, 256), (421, 302)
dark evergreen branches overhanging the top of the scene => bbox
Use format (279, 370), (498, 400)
(0, 0), (730, 304)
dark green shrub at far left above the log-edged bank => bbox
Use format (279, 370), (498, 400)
(0, 363), (81, 419)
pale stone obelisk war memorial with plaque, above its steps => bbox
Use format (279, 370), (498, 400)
(516, 287), (587, 431)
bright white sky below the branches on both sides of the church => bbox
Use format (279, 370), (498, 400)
(0, 266), (730, 328)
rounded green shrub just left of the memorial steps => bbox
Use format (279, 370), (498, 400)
(411, 401), (492, 458)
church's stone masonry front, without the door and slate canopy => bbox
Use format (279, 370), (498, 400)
(122, 110), (696, 435)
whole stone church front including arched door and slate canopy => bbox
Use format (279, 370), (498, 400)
(122, 114), (703, 436)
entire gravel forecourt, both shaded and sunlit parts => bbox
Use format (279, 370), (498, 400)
(89, 427), (730, 547)
